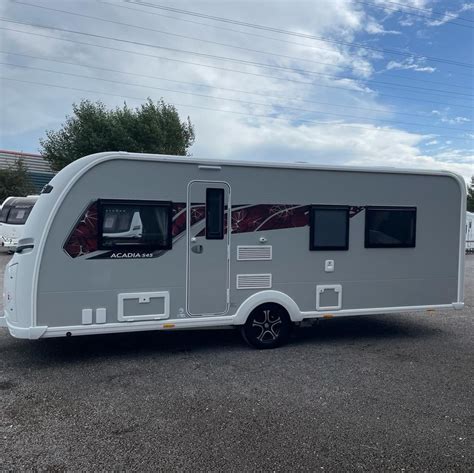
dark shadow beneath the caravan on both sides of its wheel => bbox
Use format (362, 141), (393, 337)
(3, 315), (439, 364)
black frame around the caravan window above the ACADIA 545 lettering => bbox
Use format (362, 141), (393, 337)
(97, 199), (173, 252)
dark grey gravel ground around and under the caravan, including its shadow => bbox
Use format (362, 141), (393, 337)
(0, 256), (474, 472)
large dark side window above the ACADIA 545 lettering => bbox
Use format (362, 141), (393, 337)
(99, 200), (172, 250)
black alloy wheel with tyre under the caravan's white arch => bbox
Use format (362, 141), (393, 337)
(241, 304), (293, 349)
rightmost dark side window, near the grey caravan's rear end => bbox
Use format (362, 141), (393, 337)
(365, 207), (416, 248)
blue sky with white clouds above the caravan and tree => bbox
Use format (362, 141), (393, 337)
(0, 0), (474, 180)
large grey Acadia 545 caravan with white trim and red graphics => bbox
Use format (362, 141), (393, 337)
(0, 152), (466, 348)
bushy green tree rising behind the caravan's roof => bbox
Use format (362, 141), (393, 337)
(40, 99), (194, 171)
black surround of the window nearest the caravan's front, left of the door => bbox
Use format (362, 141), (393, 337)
(97, 199), (173, 251)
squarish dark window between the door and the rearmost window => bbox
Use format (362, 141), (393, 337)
(309, 205), (349, 251)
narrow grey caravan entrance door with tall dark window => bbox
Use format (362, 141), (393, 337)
(186, 181), (231, 316)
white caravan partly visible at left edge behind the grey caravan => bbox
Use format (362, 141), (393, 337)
(0, 195), (38, 252)
